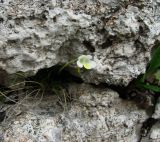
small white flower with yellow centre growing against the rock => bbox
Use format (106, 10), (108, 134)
(77, 55), (96, 69)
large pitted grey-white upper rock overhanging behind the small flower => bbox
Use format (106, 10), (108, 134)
(0, 0), (160, 85)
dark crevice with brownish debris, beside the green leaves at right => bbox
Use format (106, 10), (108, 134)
(98, 80), (157, 114)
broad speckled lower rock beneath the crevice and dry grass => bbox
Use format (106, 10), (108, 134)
(0, 84), (148, 142)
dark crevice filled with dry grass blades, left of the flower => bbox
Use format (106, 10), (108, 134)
(0, 65), (83, 122)
